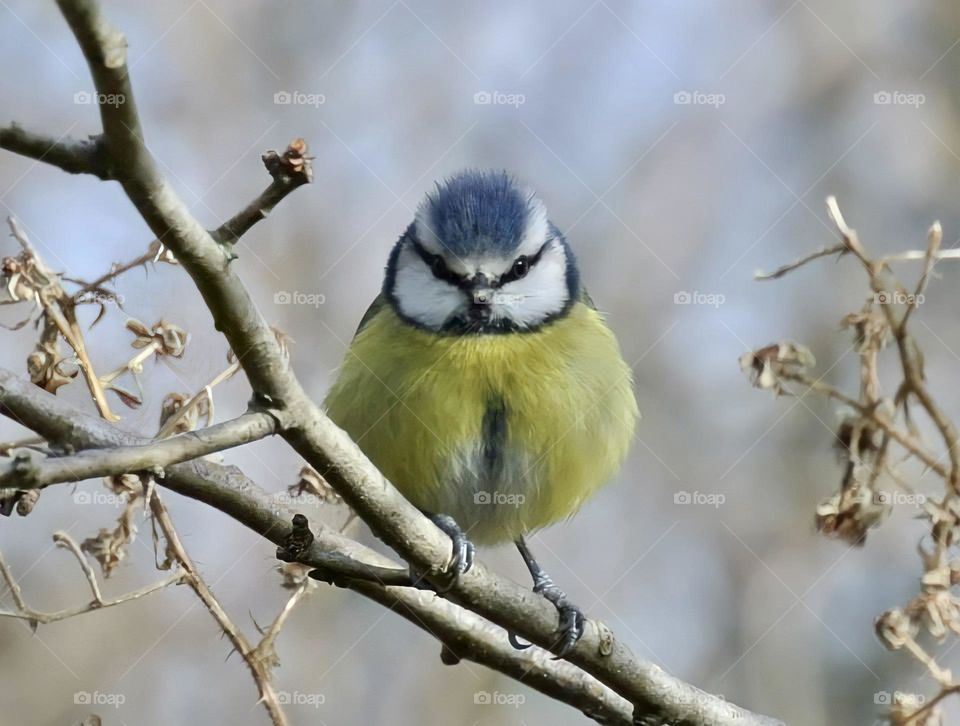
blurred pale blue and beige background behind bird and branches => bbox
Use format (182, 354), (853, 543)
(0, 0), (960, 726)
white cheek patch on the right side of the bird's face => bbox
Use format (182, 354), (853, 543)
(494, 248), (570, 327)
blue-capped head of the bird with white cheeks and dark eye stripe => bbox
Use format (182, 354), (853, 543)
(384, 171), (579, 334)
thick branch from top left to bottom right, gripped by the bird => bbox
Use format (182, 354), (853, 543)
(3, 0), (784, 726)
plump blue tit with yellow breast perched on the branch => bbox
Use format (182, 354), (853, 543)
(325, 170), (639, 657)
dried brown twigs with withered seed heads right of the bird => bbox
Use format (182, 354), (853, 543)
(741, 197), (960, 726)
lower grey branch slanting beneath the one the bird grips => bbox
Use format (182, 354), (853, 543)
(0, 369), (636, 726)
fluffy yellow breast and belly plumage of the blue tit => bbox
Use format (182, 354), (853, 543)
(326, 303), (638, 542)
